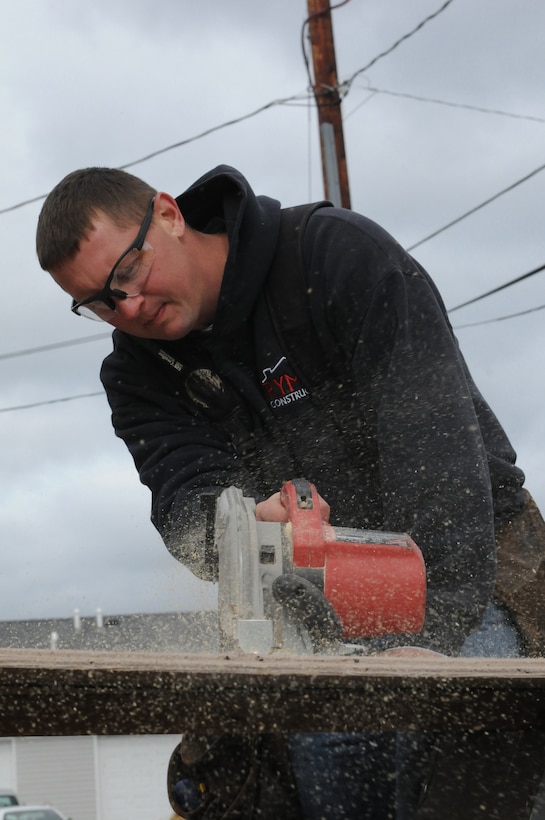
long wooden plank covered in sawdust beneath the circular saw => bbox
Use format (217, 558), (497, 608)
(0, 650), (545, 737)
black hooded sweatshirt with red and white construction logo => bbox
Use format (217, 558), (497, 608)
(101, 166), (524, 653)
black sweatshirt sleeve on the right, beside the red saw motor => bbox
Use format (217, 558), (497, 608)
(306, 213), (495, 653)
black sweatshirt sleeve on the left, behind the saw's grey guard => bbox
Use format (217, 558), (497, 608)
(101, 334), (258, 580)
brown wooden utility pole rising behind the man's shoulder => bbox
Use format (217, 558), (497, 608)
(307, 0), (350, 208)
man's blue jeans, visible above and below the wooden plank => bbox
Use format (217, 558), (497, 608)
(290, 605), (520, 820)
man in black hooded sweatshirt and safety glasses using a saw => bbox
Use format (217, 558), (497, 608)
(37, 166), (544, 820)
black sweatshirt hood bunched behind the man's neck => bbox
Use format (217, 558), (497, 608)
(176, 165), (280, 335)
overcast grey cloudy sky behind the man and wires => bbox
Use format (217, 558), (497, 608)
(0, 0), (545, 619)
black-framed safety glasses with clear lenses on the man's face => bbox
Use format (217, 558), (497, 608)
(72, 197), (155, 322)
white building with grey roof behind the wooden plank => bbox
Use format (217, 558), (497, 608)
(0, 612), (217, 820)
